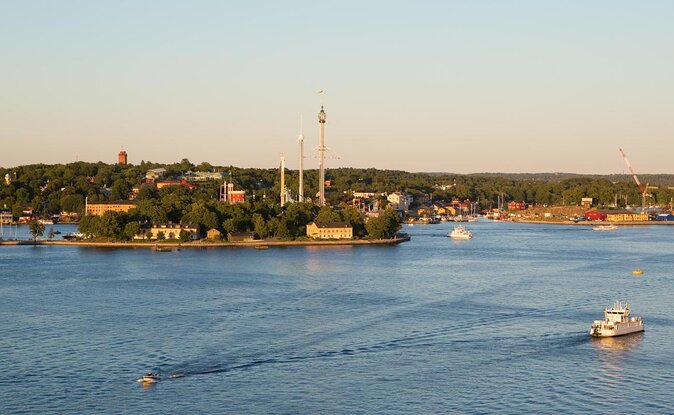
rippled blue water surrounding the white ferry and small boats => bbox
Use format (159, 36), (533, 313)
(0, 222), (674, 414)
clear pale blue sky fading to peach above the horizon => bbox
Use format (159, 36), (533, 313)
(0, 0), (674, 174)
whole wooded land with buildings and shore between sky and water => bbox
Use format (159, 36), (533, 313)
(0, 159), (674, 247)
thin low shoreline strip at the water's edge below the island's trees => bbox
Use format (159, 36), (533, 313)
(0, 236), (411, 249)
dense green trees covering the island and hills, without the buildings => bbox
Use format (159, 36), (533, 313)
(0, 159), (674, 238)
